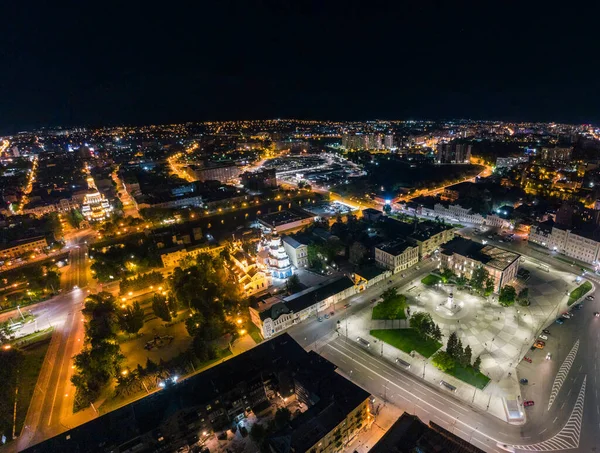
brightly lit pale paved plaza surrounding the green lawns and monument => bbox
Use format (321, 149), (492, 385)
(341, 260), (581, 417)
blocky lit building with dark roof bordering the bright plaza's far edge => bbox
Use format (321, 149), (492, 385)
(440, 237), (521, 291)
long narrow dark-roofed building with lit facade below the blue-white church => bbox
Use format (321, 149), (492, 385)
(249, 277), (356, 338)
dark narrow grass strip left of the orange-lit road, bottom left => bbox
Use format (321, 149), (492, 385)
(16, 331), (51, 435)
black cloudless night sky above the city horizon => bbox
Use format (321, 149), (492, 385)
(0, 0), (600, 133)
